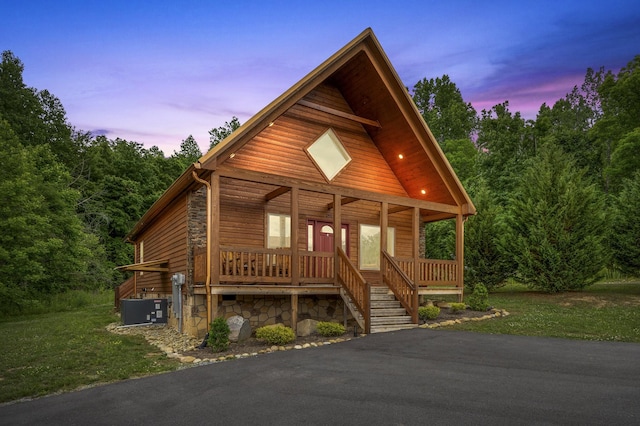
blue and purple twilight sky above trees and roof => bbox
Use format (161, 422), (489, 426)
(0, 0), (640, 156)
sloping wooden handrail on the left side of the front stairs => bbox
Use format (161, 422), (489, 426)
(336, 247), (371, 333)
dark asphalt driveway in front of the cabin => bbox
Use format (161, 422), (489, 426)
(0, 329), (640, 425)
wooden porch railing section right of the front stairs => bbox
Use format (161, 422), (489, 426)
(394, 257), (458, 287)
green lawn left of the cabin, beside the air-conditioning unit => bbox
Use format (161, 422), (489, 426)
(0, 292), (179, 402)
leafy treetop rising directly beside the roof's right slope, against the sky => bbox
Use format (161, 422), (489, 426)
(413, 74), (477, 144)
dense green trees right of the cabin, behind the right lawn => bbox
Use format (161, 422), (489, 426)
(412, 59), (640, 292)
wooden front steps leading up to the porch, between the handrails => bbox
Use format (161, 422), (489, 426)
(371, 286), (418, 333)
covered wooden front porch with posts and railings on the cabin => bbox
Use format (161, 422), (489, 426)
(193, 168), (465, 331)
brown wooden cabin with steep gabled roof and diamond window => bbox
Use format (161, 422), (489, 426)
(116, 29), (475, 337)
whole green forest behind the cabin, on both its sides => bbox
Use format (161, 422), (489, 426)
(0, 51), (640, 311)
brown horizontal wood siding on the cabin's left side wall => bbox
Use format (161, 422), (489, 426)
(135, 196), (187, 293)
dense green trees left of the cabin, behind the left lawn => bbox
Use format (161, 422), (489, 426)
(0, 51), (245, 312)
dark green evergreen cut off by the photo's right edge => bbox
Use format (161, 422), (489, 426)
(610, 171), (640, 276)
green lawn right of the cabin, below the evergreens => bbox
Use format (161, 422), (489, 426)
(450, 281), (640, 343)
